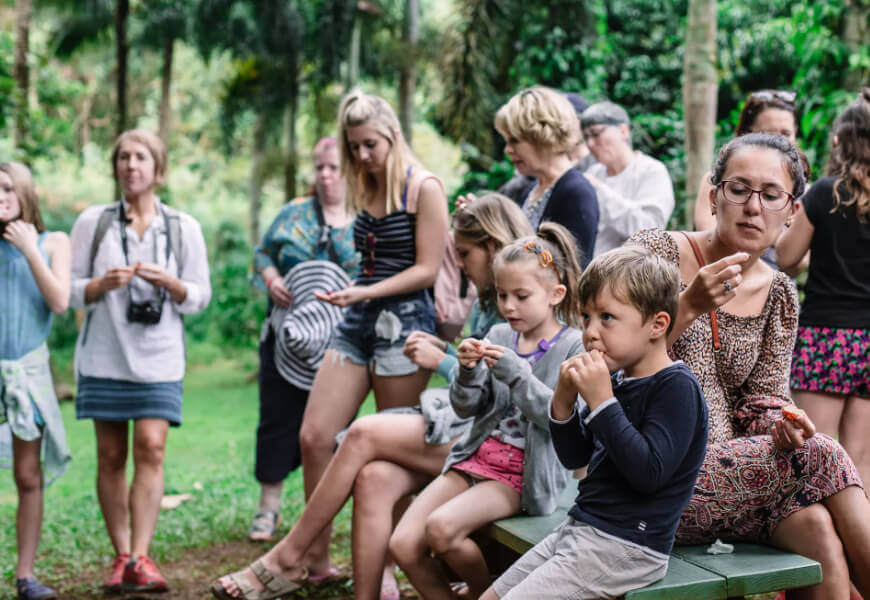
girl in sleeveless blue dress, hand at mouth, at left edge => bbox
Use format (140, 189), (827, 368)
(0, 163), (70, 600)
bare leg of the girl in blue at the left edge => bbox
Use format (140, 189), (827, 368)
(12, 435), (43, 579)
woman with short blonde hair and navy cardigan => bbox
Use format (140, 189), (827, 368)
(495, 86), (598, 265)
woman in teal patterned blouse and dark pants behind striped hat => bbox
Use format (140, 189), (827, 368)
(249, 137), (359, 541)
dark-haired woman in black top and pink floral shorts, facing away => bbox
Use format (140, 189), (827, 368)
(776, 88), (870, 510)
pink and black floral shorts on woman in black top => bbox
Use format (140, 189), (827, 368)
(791, 327), (870, 398)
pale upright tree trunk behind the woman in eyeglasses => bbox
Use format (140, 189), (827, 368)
(683, 0), (718, 228)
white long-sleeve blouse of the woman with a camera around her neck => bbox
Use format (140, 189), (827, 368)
(70, 200), (211, 383)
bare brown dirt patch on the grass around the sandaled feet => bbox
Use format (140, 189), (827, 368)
(46, 541), (418, 600)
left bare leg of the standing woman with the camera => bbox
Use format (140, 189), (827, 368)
(94, 421), (130, 554)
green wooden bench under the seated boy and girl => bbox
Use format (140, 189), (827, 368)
(479, 485), (822, 600)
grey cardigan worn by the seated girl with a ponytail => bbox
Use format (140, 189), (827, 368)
(450, 323), (583, 515)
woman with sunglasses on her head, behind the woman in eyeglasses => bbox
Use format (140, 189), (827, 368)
(694, 90), (798, 231)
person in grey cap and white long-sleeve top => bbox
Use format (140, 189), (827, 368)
(580, 102), (674, 256)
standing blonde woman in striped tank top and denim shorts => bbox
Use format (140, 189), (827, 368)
(290, 90), (448, 582)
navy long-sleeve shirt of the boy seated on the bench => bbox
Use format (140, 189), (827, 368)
(550, 362), (707, 554)
